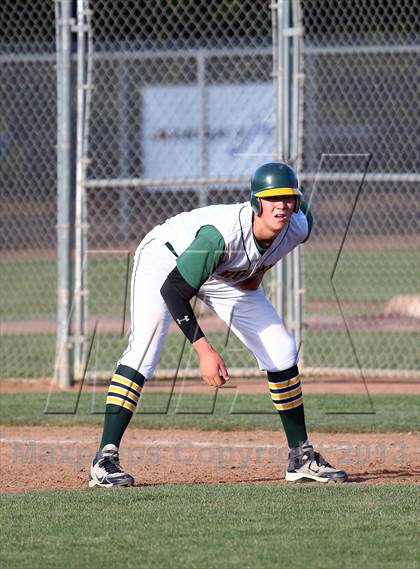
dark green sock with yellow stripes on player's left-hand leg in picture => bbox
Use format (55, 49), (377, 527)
(99, 365), (145, 449)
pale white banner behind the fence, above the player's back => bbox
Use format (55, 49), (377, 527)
(141, 83), (275, 178)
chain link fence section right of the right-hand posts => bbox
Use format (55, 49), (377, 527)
(302, 0), (420, 376)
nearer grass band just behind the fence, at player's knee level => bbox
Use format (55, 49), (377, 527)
(0, 330), (420, 377)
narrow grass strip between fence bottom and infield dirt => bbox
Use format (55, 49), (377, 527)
(0, 388), (420, 432)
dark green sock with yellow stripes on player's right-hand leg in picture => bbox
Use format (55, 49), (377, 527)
(267, 365), (308, 448)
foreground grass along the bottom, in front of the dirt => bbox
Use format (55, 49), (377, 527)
(0, 484), (420, 569)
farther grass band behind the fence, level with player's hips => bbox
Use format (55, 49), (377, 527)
(0, 246), (420, 320)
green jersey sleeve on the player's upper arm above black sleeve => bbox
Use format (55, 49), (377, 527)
(176, 225), (225, 290)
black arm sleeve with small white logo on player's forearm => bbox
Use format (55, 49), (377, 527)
(160, 268), (204, 344)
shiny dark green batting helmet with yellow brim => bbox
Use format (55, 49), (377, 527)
(250, 162), (302, 215)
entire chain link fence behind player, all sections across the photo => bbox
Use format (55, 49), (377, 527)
(0, 0), (420, 377)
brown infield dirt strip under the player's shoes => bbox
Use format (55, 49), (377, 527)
(0, 426), (420, 492)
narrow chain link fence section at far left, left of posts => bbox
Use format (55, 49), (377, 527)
(0, 0), (57, 377)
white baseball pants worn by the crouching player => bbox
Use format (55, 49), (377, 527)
(118, 230), (297, 380)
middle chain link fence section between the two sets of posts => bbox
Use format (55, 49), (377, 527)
(80, 0), (276, 382)
